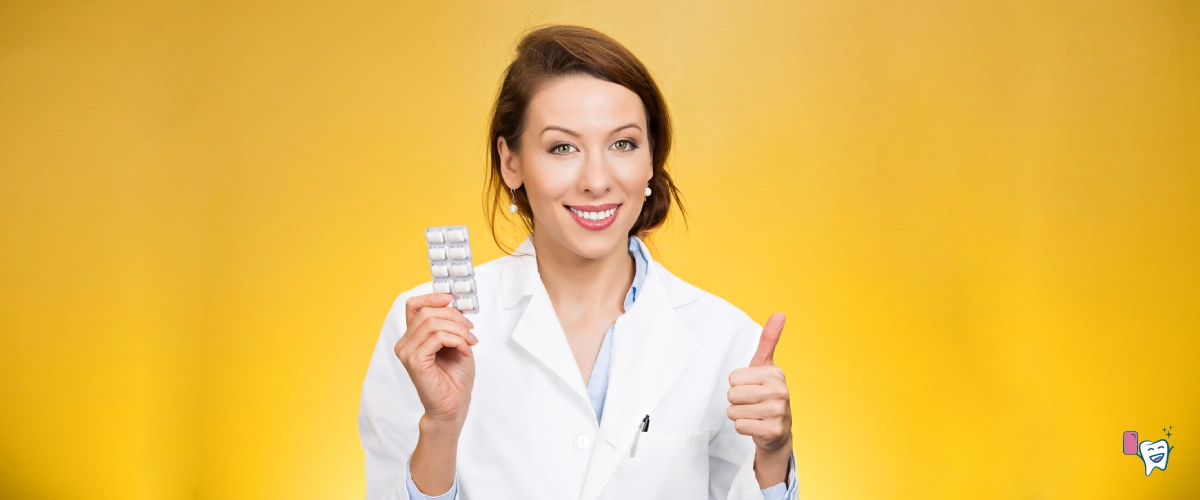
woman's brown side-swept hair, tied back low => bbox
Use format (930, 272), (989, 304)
(484, 25), (688, 253)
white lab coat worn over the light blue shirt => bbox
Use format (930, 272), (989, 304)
(359, 239), (796, 500)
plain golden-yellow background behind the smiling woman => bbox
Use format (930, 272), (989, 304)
(0, 0), (1200, 500)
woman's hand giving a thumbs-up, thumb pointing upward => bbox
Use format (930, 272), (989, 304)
(727, 313), (792, 450)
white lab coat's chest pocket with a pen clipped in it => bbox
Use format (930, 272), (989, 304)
(606, 430), (708, 499)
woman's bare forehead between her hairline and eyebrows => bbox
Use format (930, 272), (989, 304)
(527, 74), (646, 130)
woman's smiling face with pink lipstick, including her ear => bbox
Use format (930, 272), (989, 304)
(498, 76), (654, 259)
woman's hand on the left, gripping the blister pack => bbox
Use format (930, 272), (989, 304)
(395, 294), (479, 430)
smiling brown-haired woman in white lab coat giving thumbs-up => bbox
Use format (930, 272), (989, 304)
(359, 26), (798, 500)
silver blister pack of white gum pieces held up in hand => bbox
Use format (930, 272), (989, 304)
(425, 225), (479, 313)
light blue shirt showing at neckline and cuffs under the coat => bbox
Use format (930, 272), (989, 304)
(404, 237), (796, 500)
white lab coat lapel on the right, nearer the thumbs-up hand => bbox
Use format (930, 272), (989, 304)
(581, 256), (700, 500)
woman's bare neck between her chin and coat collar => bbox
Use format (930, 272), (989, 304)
(533, 233), (635, 314)
